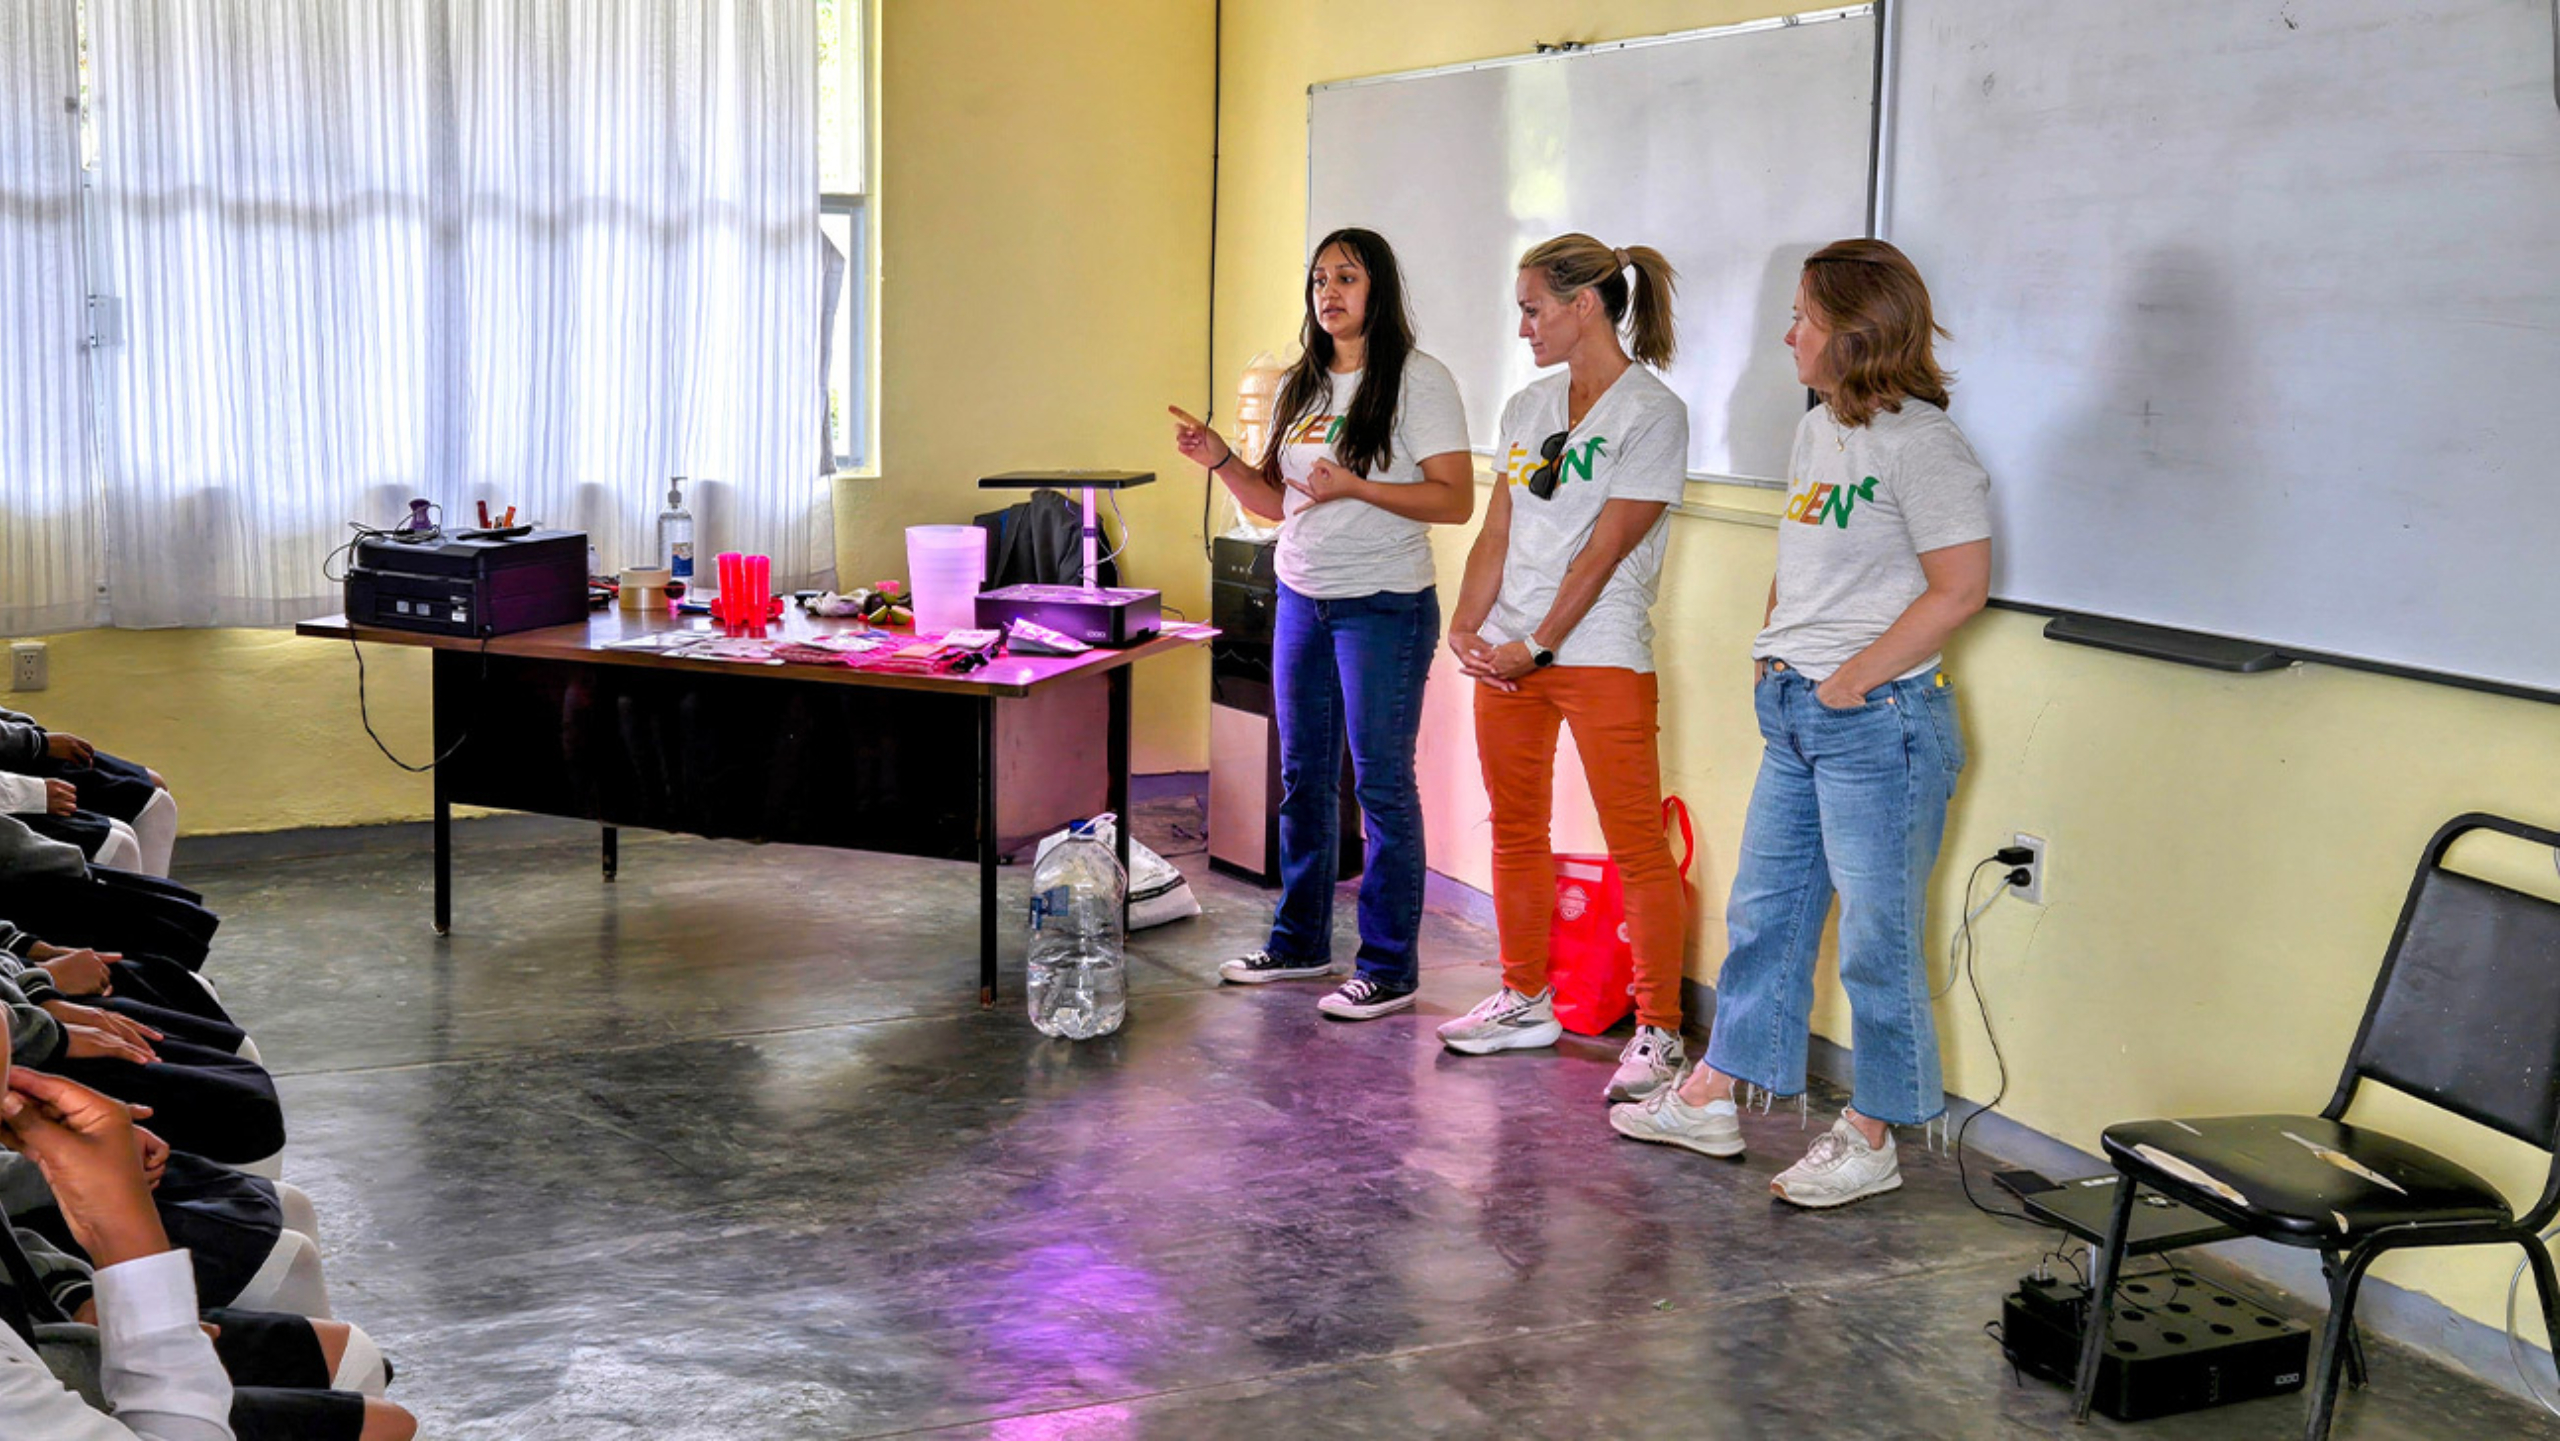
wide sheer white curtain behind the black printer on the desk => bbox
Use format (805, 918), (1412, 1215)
(90, 0), (829, 625)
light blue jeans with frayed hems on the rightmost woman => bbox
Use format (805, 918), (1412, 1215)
(1708, 671), (1964, 1126)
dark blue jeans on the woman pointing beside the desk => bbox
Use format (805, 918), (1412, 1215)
(1270, 584), (1439, 991)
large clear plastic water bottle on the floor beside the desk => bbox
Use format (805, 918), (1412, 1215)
(1029, 816), (1129, 1042)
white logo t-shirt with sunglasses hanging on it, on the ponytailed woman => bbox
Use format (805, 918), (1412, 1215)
(1482, 366), (1690, 671)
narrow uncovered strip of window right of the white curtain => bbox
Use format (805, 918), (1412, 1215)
(817, 0), (870, 471)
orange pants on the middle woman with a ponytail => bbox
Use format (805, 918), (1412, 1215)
(1475, 665), (1687, 1031)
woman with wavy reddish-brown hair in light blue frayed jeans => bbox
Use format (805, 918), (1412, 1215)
(1610, 241), (1992, 1208)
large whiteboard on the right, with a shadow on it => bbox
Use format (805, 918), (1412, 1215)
(1882, 0), (2560, 691)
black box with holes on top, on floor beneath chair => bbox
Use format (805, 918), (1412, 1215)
(1999, 1272), (2312, 1421)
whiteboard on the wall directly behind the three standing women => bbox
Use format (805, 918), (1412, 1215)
(1306, 5), (1879, 481)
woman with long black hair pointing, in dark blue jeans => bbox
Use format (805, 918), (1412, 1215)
(1172, 230), (1475, 1021)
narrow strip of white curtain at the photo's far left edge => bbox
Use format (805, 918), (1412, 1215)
(0, 0), (102, 635)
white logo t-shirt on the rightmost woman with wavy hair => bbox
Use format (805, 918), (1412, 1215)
(1751, 399), (1992, 681)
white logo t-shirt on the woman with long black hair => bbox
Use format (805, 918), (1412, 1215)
(1272, 351), (1472, 601)
